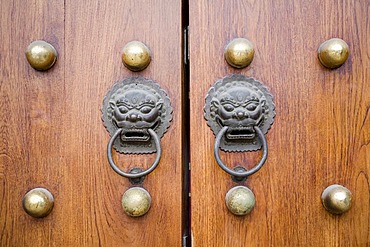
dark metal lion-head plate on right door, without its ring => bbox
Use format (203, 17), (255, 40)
(204, 75), (275, 152)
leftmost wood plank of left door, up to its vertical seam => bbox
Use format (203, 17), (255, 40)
(0, 1), (66, 246)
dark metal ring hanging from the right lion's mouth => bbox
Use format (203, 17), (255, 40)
(214, 126), (268, 177)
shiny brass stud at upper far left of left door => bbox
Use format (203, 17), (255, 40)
(26, 40), (58, 71)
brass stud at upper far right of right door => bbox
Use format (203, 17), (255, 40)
(317, 38), (349, 69)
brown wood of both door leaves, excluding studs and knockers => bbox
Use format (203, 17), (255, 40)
(0, 0), (370, 246)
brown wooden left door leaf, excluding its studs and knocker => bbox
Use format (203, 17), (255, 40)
(0, 0), (183, 246)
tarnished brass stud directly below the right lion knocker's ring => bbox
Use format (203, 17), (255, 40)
(225, 186), (256, 215)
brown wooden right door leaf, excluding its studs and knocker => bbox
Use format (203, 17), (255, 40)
(189, 0), (370, 247)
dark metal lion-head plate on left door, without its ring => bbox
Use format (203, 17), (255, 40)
(102, 77), (172, 154)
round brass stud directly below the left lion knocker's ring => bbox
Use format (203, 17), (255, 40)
(122, 187), (152, 217)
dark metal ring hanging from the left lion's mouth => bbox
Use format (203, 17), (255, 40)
(107, 128), (162, 178)
